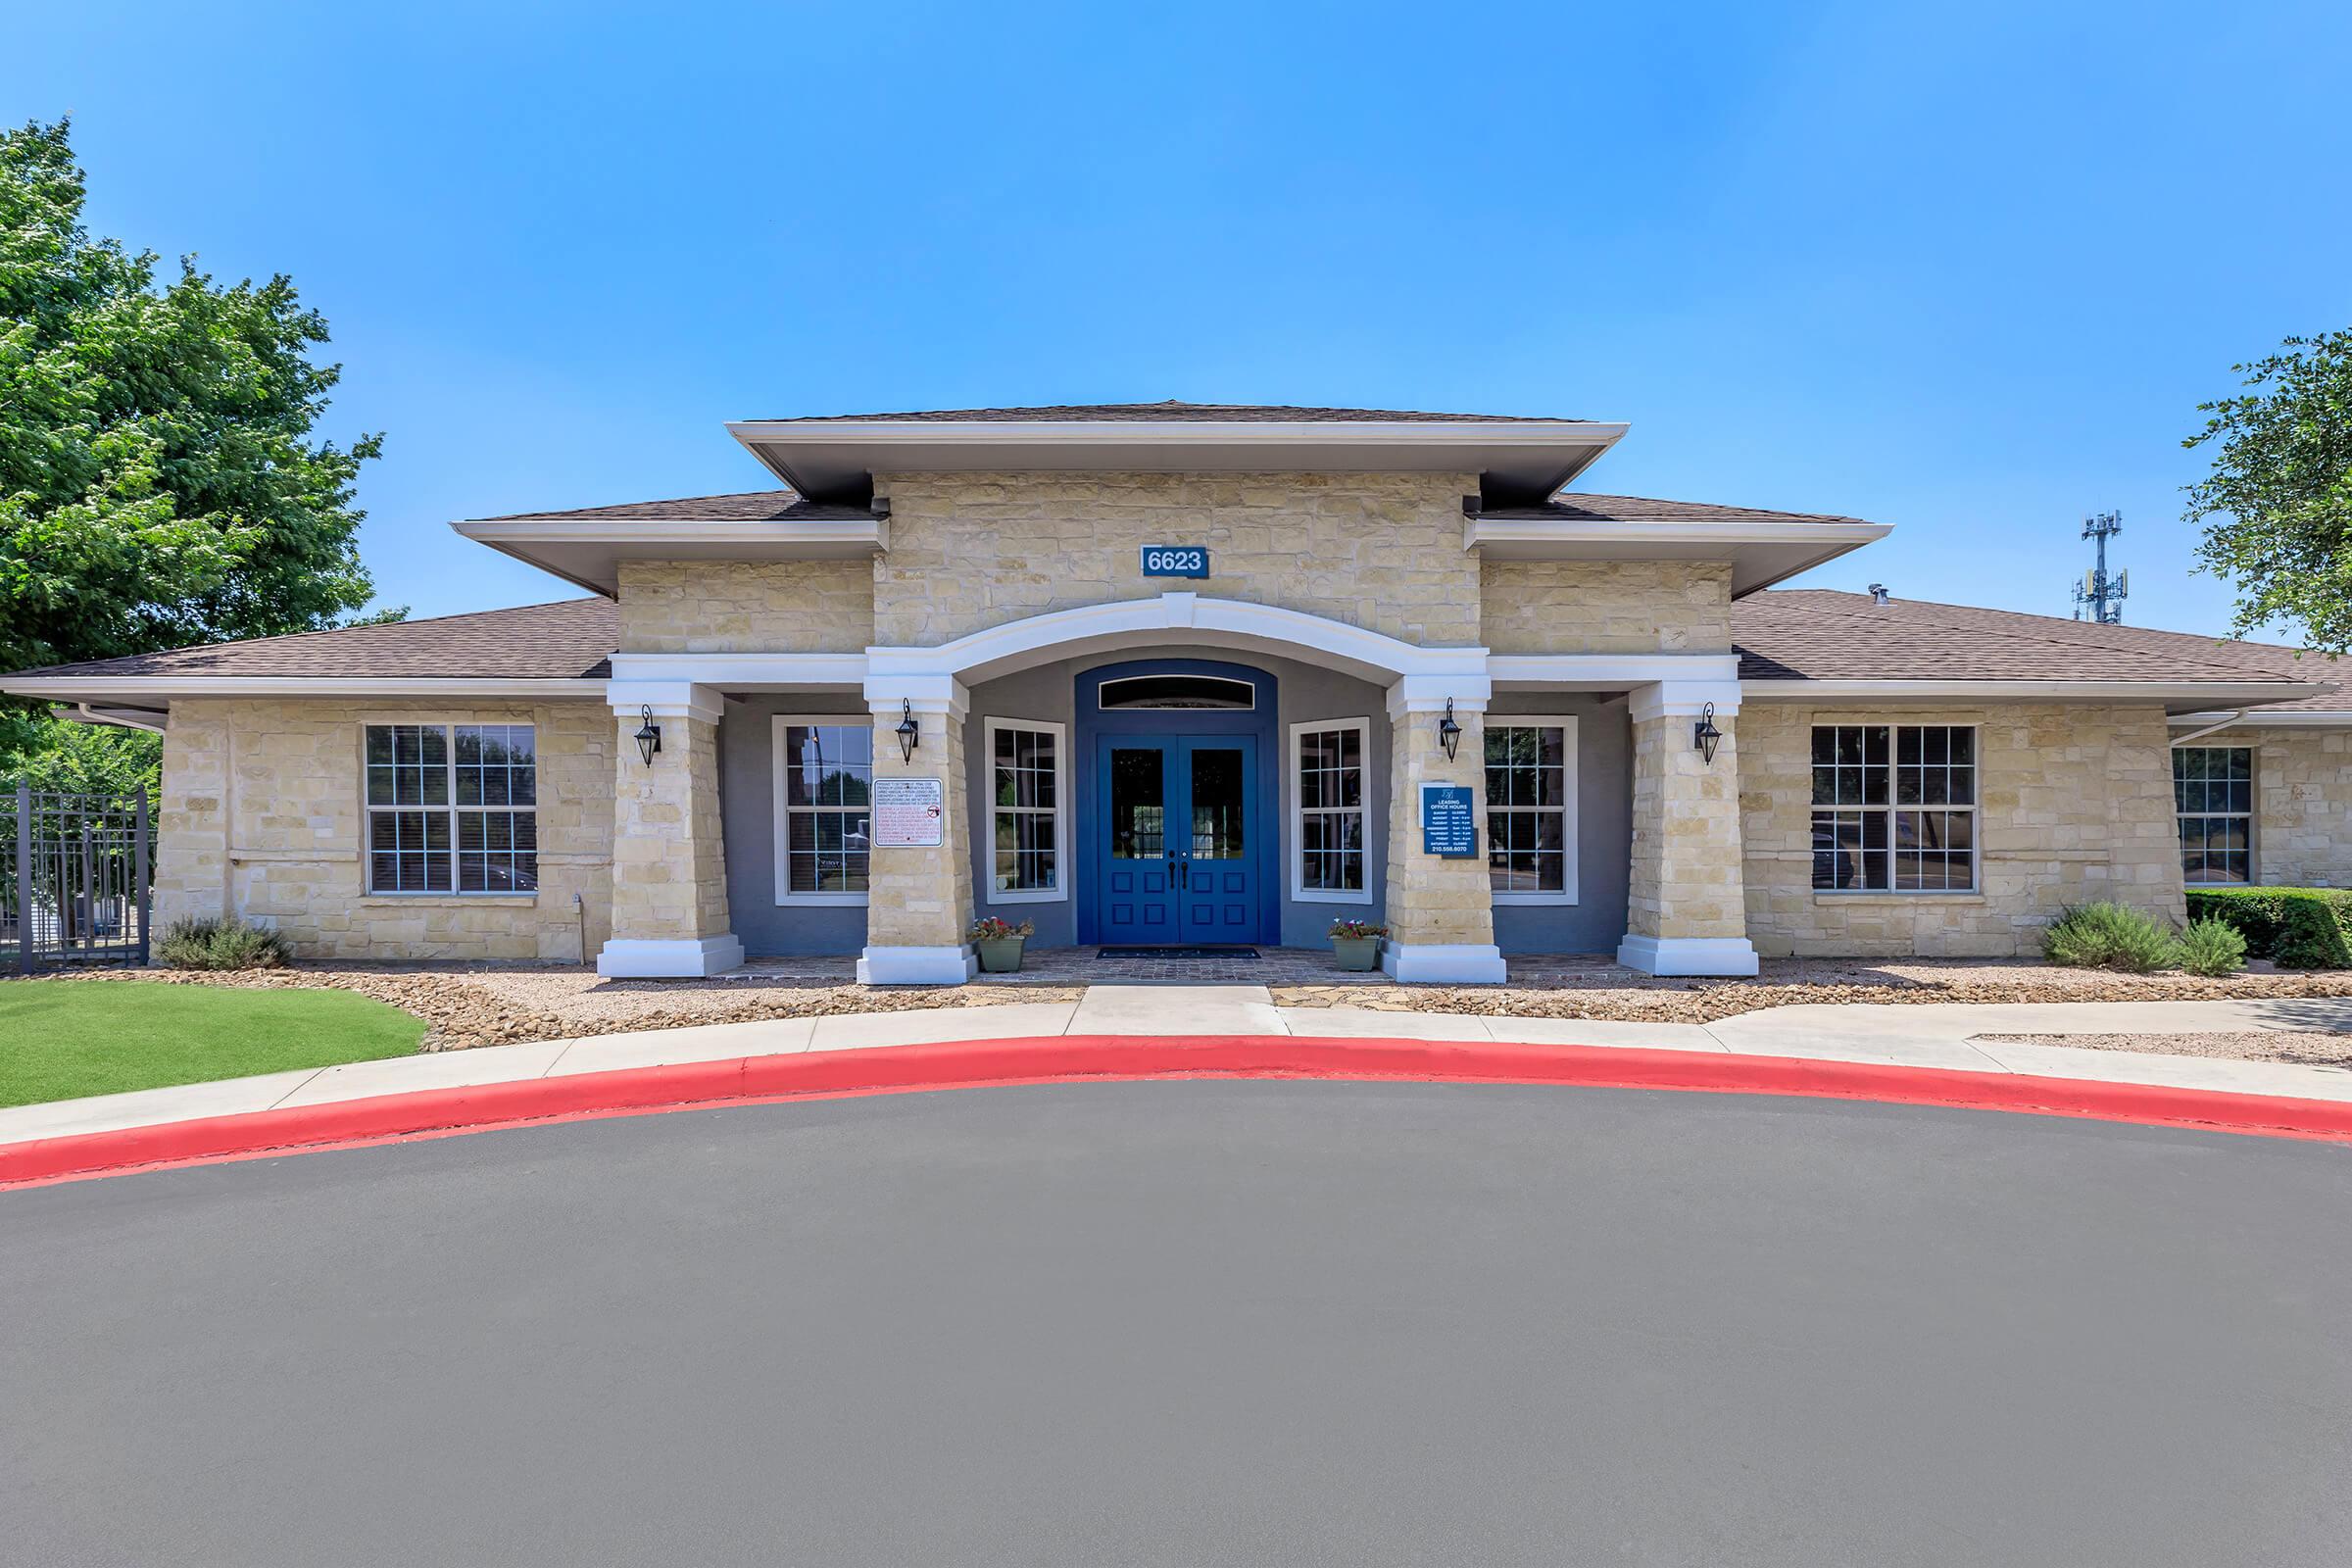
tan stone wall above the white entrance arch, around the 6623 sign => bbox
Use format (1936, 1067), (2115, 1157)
(872, 472), (1480, 647)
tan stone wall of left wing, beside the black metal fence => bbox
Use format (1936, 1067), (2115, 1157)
(155, 701), (613, 961)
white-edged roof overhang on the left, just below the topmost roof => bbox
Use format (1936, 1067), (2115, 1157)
(449, 517), (889, 600)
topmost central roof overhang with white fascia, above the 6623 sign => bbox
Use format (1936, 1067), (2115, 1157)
(727, 418), (1625, 503)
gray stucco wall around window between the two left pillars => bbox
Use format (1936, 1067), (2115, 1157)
(719, 691), (865, 956)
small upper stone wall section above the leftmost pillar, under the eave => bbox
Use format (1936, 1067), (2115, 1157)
(618, 560), (875, 654)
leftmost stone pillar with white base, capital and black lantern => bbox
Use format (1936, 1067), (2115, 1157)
(595, 682), (743, 978)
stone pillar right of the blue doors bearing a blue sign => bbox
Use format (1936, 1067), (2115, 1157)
(1381, 674), (1505, 985)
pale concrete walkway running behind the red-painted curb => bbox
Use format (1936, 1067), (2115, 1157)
(0, 985), (2352, 1145)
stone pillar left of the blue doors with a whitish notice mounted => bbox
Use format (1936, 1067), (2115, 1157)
(858, 674), (978, 985)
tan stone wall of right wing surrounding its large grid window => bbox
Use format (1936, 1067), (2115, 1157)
(1740, 703), (2187, 956)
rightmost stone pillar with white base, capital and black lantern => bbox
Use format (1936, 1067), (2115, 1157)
(1618, 682), (1757, 976)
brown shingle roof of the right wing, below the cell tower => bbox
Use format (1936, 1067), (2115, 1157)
(1731, 588), (2352, 710)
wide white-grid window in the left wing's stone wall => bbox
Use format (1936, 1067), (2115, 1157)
(365, 724), (539, 894)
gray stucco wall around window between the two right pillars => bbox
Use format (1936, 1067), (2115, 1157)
(1487, 691), (1633, 955)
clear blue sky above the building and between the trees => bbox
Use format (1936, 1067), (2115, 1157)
(18, 0), (2352, 630)
